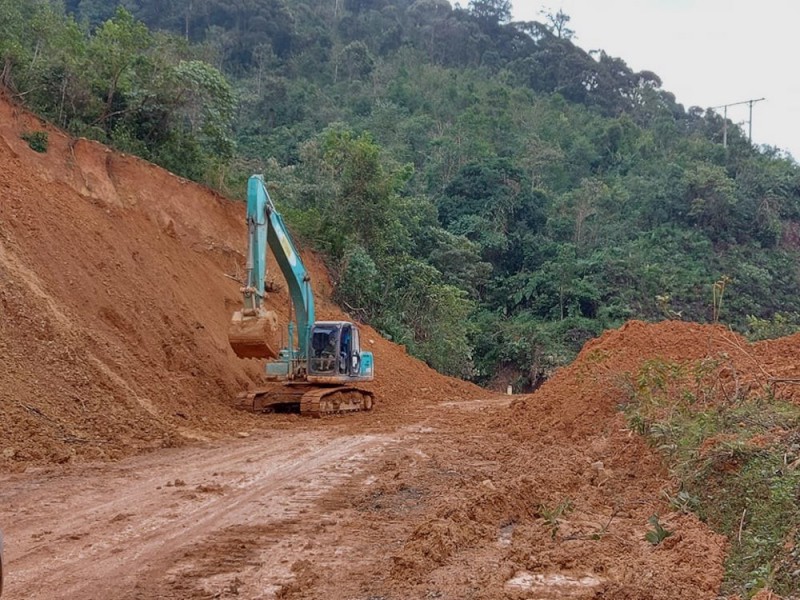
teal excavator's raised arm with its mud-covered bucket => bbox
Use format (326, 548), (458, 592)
(228, 175), (314, 360)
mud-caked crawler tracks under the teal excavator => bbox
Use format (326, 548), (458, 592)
(237, 385), (373, 418)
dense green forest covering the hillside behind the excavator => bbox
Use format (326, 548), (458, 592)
(0, 0), (800, 390)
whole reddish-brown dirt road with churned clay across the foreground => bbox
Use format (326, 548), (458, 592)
(0, 384), (724, 600)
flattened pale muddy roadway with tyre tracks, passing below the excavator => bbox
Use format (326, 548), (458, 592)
(0, 399), (508, 600)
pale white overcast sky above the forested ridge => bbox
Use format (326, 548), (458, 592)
(512, 0), (800, 160)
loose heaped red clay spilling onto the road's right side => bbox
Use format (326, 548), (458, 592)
(286, 322), (800, 600)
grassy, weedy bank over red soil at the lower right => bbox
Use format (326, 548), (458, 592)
(622, 356), (800, 598)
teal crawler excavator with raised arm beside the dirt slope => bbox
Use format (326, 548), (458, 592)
(228, 175), (375, 417)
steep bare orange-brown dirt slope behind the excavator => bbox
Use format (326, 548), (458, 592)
(0, 99), (480, 468)
